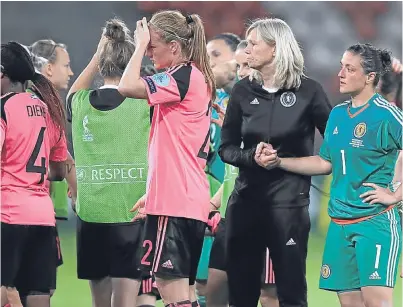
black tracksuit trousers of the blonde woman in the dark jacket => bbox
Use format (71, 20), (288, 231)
(226, 191), (311, 307)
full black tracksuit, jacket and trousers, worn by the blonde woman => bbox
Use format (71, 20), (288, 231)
(219, 78), (331, 307)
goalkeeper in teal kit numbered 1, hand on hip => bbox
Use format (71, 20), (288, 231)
(264, 44), (403, 307)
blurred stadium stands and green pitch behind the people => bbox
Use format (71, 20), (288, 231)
(1, 1), (402, 307)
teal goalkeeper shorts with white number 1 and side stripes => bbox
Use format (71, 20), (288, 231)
(319, 207), (402, 291)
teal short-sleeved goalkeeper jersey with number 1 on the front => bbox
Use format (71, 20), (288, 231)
(319, 94), (403, 220)
